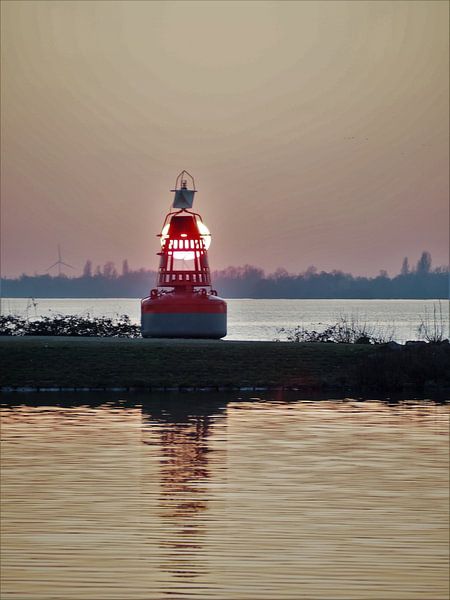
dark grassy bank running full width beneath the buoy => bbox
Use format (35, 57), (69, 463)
(0, 337), (450, 394)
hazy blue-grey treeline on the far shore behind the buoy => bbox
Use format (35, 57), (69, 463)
(1, 252), (449, 299)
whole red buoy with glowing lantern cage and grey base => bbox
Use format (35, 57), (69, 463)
(141, 171), (227, 339)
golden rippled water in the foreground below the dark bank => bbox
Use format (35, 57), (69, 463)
(2, 394), (449, 600)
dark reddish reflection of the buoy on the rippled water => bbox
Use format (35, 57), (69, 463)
(142, 397), (226, 578)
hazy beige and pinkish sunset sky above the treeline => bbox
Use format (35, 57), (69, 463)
(1, 0), (449, 276)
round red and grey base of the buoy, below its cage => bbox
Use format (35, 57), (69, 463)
(141, 293), (227, 339)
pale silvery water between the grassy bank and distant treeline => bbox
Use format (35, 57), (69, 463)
(1, 298), (449, 342)
